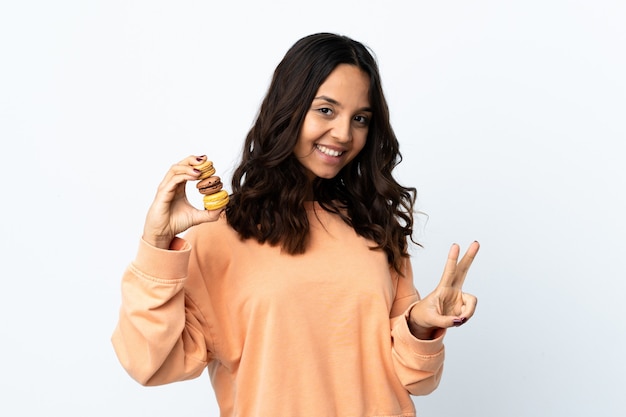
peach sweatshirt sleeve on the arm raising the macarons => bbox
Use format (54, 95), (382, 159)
(111, 239), (209, 385)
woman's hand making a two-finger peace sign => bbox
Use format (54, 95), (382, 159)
(409, 242), (480, 340)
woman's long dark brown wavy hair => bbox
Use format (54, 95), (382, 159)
(226, 33), (416, 272)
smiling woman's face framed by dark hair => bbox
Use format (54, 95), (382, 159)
(293, 64), (372, 179)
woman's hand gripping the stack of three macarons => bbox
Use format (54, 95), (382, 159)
(143, 155), (223, 249)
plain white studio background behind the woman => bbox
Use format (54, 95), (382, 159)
(0, 0), (626, 417)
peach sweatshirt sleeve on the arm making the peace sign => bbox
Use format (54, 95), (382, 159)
(391, 258), (445, 395)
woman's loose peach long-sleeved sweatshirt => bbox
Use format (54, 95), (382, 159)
(112, 204), (444, 417)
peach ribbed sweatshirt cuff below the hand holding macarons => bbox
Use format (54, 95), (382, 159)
(133, 237), (191, 280)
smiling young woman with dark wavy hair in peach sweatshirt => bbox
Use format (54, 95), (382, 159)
(112, 33), (478, 417)
